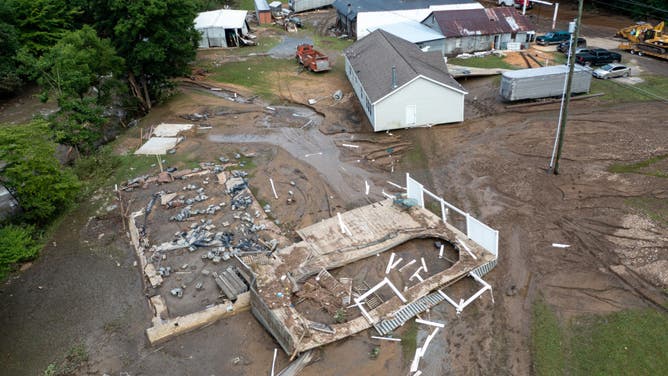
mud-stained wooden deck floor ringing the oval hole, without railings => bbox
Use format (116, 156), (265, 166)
(257, 199), (496, 354)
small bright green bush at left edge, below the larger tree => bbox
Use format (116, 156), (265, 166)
(0, 225), (40, 280)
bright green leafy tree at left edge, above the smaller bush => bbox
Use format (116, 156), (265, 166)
(0, 120), (80, 224)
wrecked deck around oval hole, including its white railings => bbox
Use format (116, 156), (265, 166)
(251, 176), (498, 355)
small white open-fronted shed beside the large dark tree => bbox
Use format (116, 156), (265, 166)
(195, 9), (249, 48)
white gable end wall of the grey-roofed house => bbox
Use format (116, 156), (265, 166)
(373, 78), (464, 132)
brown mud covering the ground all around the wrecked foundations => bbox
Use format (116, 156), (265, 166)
(0, 5), (668, 375)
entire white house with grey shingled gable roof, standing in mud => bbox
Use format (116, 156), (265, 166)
(344, 29), (467, 132)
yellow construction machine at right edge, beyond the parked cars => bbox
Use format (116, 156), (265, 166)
(618, 22), (668, 60)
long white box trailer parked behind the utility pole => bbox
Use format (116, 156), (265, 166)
(499, 64), (592, 101)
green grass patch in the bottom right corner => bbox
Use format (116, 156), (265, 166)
(531, 300), (668, 376)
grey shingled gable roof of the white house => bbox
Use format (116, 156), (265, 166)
(344, 29), (465, 103)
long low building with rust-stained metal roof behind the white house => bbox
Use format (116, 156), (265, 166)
(422, 7), (536, 55)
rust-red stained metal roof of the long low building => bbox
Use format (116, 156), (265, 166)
(423, 7), (535, 38)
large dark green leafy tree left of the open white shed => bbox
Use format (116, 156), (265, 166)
(95, 0), (200, 112)
